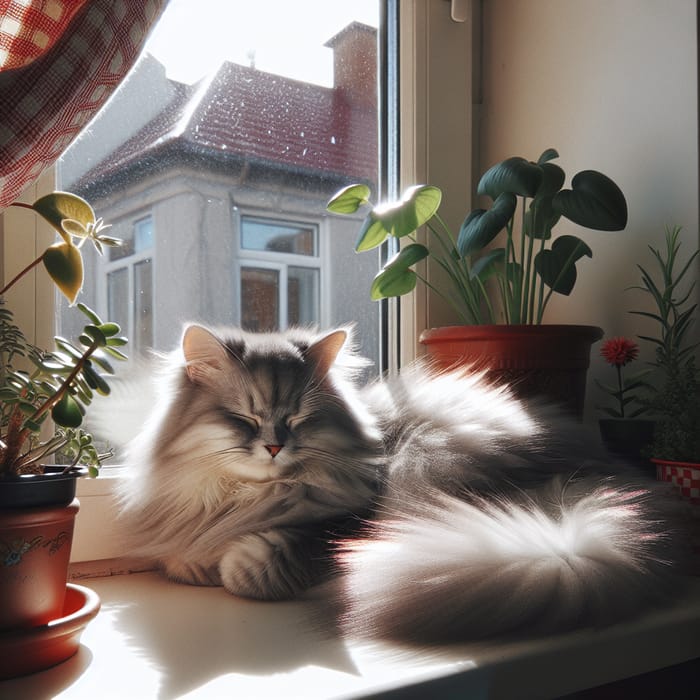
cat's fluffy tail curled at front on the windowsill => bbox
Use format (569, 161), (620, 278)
(339, 486), (680, 641)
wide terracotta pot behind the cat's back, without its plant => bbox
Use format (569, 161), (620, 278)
(420, 325), (603, 419)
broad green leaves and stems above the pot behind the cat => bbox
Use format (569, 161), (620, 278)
(328, 148), (627, 324)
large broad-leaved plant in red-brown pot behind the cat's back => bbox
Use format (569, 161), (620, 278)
(328, 148), (627, 416)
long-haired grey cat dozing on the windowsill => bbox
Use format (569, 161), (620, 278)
(121, 325), (682, 641)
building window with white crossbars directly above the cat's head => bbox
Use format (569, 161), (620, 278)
(238, 216), (321, 331)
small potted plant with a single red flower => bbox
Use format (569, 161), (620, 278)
(596, 337), (654, 463)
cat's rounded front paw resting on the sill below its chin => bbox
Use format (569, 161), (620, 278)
(219, 530), (310, 600)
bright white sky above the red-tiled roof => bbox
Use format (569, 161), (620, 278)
(146, 0), (379, 86)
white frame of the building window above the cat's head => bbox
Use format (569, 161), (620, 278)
(233, 209), (330, 330)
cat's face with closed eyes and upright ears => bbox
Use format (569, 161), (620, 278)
(174, 326), (366, 482)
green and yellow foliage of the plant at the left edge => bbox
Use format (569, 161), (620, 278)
(0, 192), (127, 477)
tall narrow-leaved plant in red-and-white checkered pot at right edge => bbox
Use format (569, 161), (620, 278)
(632, 226), (700, 504)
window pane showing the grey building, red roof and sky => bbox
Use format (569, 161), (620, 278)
(58, 0), (381, 456)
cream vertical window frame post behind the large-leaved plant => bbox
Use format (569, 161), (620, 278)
(399, 0), (480, 364)
